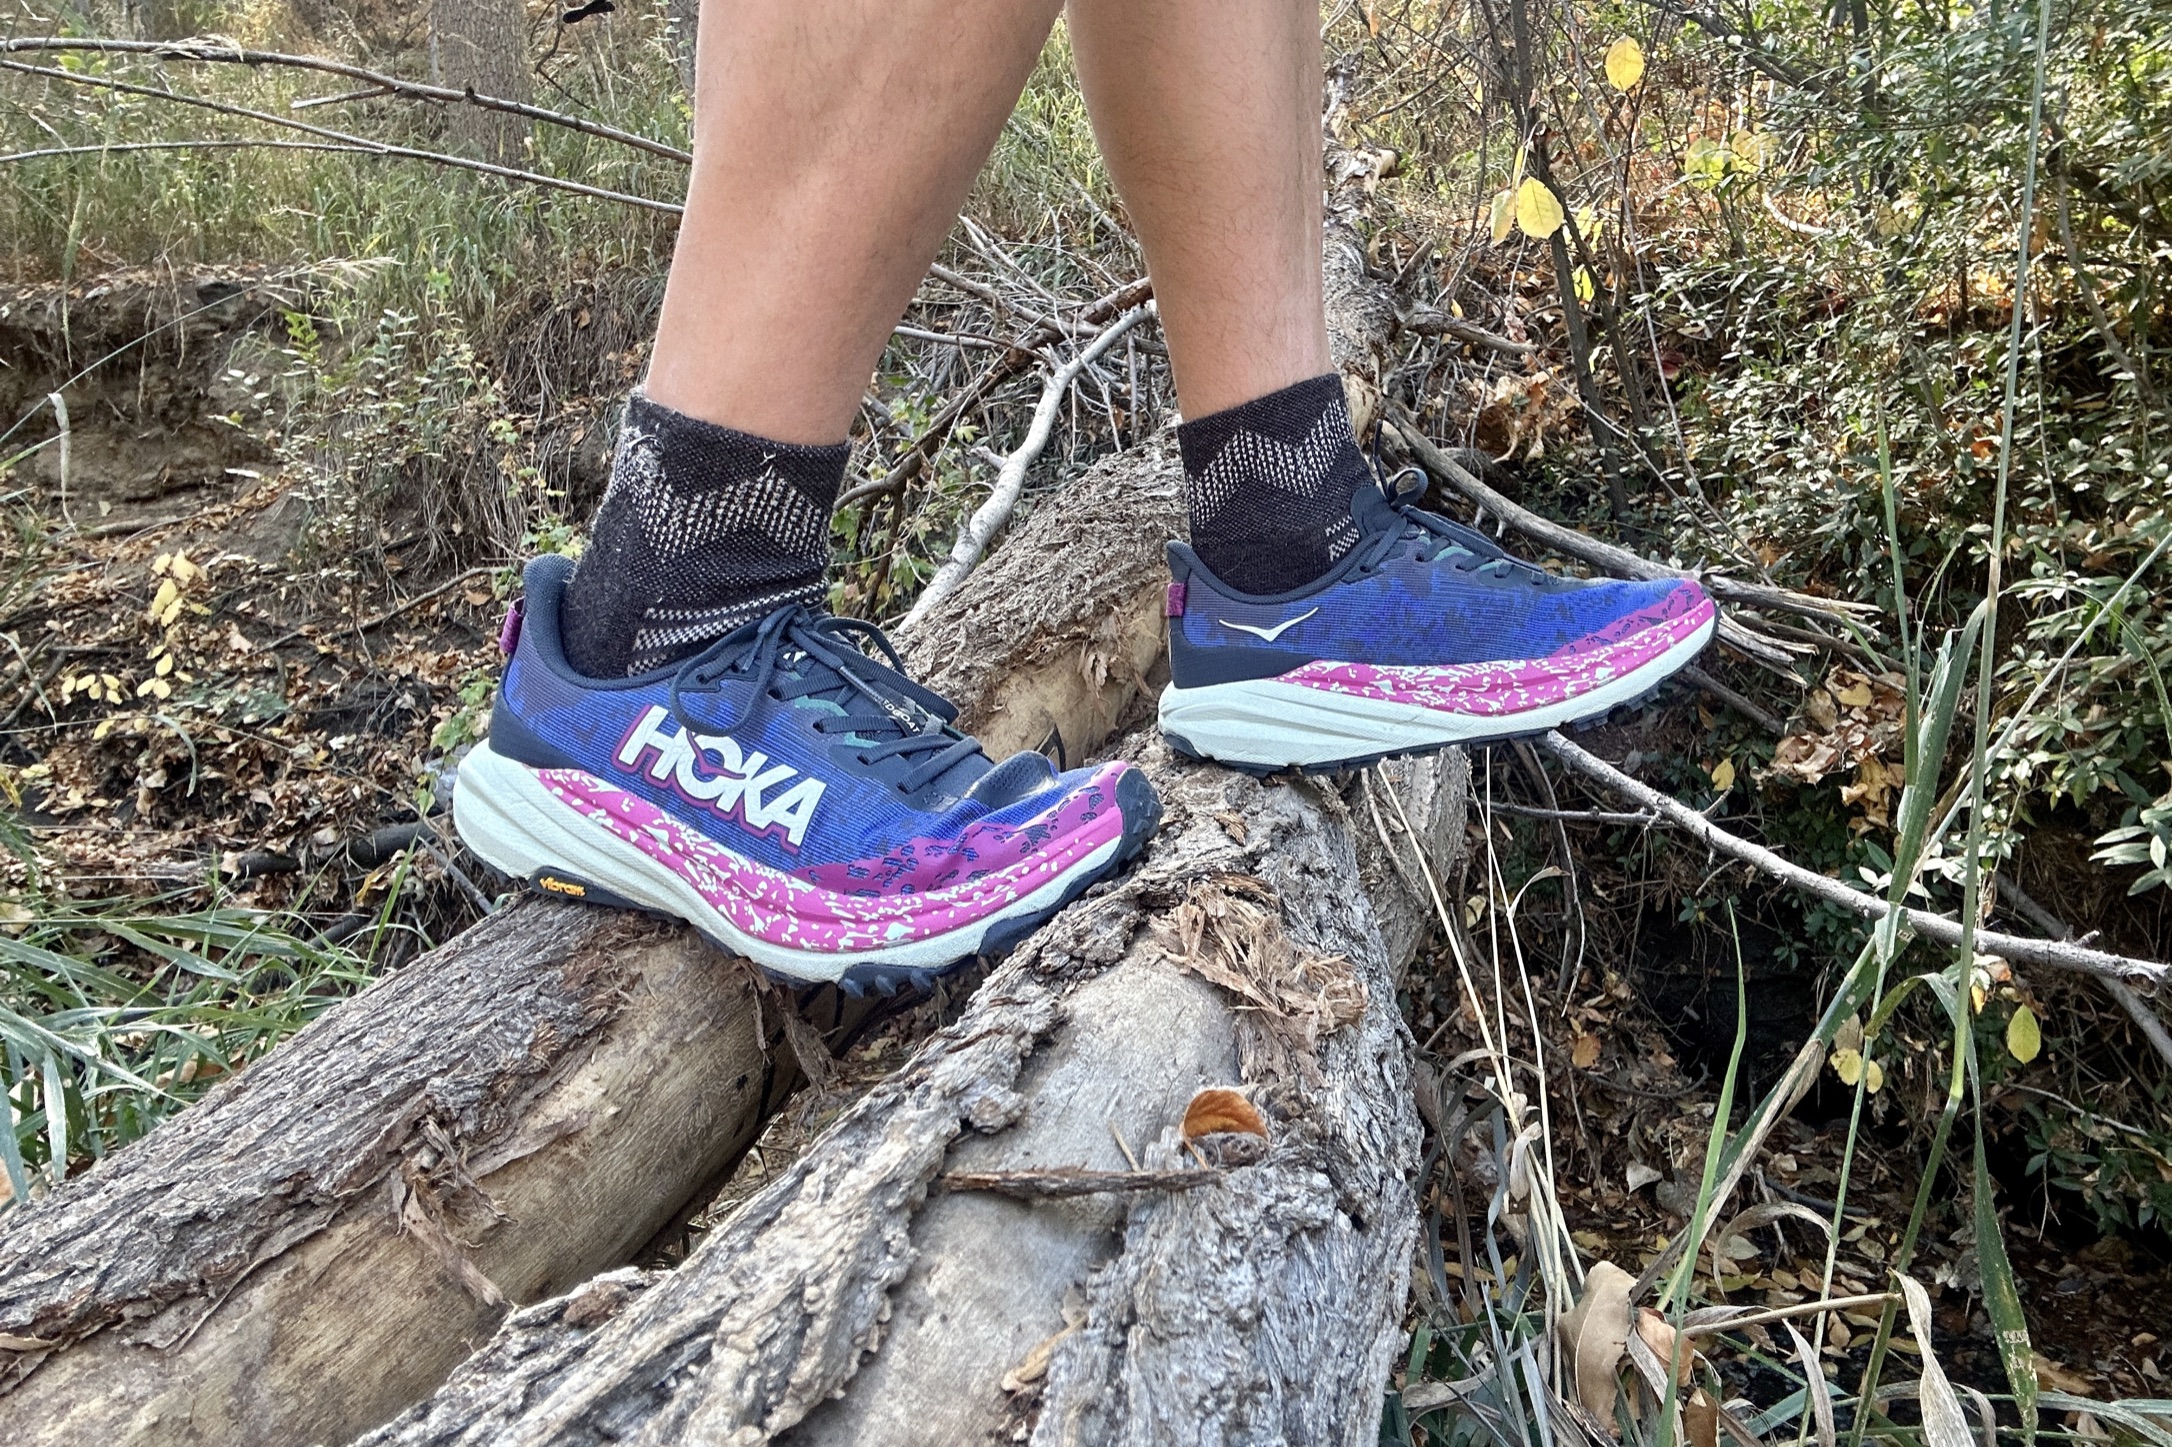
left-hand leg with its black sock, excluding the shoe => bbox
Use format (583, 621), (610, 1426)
(567, 0), (1058, 676)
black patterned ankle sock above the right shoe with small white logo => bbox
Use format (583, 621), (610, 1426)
(1177, 374), (1373, 593)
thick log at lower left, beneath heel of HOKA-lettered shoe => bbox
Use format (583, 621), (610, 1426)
(0, 902), (793, 1445)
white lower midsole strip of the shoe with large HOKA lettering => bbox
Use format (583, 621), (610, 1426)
(452, 743), (1123, 982)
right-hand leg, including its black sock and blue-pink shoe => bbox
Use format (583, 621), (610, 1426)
(1069, 0), (1716, 771)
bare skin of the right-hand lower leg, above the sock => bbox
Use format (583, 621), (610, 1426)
(1069, 0), (1331, 417)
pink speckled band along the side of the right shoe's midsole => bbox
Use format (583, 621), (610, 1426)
(1277, 600), (1714, 717)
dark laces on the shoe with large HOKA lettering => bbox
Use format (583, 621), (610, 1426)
(671, 604), (980, 793)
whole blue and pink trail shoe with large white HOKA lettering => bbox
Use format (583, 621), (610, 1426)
(452, 556), (1162, 993)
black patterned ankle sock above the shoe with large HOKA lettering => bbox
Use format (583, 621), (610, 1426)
(563, 393), (851, 678)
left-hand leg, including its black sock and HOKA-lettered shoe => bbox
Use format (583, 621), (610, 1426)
(454, 0), (1160, 989)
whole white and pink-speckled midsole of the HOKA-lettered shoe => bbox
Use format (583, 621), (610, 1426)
(454, 745), (1125, 978)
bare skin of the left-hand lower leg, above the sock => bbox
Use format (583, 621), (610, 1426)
(647, 0), (1072, 443)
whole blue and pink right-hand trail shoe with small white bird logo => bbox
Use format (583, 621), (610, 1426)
(1162, 474), (1718, 773)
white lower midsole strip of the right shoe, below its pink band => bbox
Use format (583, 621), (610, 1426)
(1160, 617), (1718, 769)
